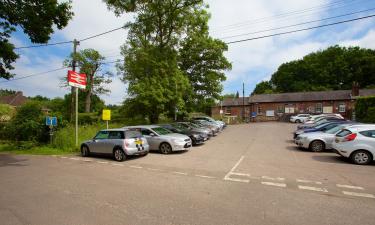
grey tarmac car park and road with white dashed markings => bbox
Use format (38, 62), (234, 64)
(0, 122), (375, 224)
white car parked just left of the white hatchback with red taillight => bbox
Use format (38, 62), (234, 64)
(295, 123), (353, 152)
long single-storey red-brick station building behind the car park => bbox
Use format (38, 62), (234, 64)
(211, 87), (375, 121)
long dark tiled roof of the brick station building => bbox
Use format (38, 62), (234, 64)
(249, 89), (375, 103)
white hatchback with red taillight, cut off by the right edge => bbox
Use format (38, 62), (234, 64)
(332, 125), (375, 165)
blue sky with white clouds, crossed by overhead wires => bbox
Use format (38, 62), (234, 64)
(0, 0), (375, 104)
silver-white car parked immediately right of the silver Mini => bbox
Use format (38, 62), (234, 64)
(125, 125), (192, 154)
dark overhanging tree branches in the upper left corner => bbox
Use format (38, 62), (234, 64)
(0, 0), (73, 79)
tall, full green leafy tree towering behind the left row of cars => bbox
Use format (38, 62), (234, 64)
(105, 0), (231, 123)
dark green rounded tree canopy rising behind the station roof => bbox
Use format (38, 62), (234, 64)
(255, 46), (375, 94)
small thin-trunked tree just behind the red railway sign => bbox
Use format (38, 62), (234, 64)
(64, 49), (112, 113)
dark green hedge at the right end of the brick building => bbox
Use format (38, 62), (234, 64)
(355, 96), (375, 123)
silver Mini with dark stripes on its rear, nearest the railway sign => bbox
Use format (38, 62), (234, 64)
(81, 128), (149, 161)
